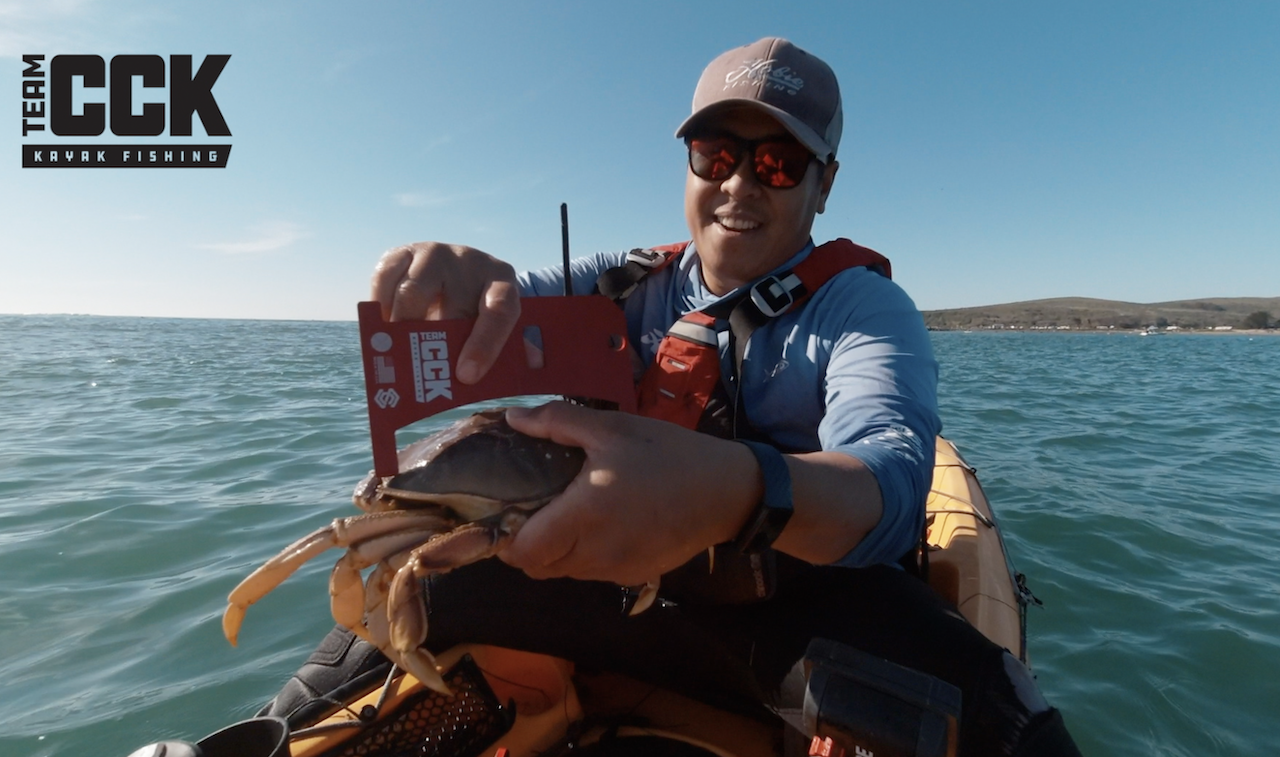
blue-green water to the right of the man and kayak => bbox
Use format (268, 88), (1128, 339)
(934, 334), (1280, 757)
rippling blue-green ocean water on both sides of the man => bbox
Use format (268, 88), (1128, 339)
(0, 316), (1280, 757)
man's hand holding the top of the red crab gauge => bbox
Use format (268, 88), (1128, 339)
(372, 242), (520, 384)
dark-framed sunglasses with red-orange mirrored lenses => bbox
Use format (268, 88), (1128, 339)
(687, 136), (818, 190)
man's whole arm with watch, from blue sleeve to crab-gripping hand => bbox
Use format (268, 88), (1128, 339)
(503, 274), (938, 584)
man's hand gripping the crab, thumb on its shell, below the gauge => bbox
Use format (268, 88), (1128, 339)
(499, 402), (760, 585)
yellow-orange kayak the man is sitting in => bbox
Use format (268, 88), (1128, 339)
(272, 437), (1028, 757)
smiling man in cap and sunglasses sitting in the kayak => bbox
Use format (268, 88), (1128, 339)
(272, 38), (1074, 754)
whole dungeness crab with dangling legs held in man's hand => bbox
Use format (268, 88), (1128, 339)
(223, 410), (655, 693)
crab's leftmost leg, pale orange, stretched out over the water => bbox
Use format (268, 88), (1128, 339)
(223, 510), (454, 646)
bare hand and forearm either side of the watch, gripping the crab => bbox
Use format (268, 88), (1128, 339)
(499, 402), (883, 585)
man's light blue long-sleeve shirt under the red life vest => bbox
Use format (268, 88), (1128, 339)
(518, 242), (941, 567)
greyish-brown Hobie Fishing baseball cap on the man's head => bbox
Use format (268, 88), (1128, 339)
(676, 37), (845, 163)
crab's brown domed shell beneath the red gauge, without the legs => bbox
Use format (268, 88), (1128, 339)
(353, 409), (586, 523)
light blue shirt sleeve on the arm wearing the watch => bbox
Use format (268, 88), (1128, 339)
(818, 275), (942, 567)
